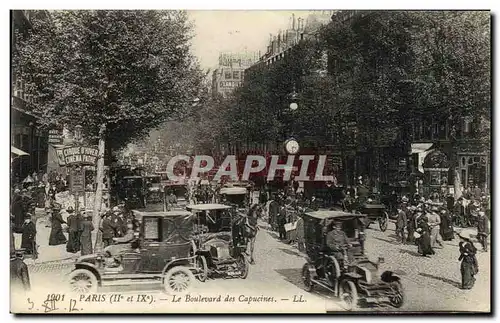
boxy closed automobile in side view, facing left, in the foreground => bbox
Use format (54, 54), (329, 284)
(68, 210), (200, 294)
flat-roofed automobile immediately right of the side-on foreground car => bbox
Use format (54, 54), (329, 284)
(187, 204), (249, 281)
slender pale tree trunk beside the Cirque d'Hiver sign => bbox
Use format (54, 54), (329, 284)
(92, 124), (106, 251)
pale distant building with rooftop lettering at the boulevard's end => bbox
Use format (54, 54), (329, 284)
(212, 53), (258, 97)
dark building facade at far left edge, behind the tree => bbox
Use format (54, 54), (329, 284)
(10, 10), (50, 182)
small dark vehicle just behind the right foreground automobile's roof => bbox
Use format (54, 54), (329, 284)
(345, 194), (389, 232)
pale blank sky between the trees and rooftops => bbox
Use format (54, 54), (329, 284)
(189, 10), (310, 69)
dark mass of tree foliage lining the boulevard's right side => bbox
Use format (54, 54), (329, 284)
(213, 11), (491, 156)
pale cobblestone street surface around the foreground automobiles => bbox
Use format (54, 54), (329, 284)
(22, 215), (490, 312)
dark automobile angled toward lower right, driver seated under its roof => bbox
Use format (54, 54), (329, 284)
(302, 210), (404, 310)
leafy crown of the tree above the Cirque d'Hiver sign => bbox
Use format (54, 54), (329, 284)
(14, 10), (203, 149)
